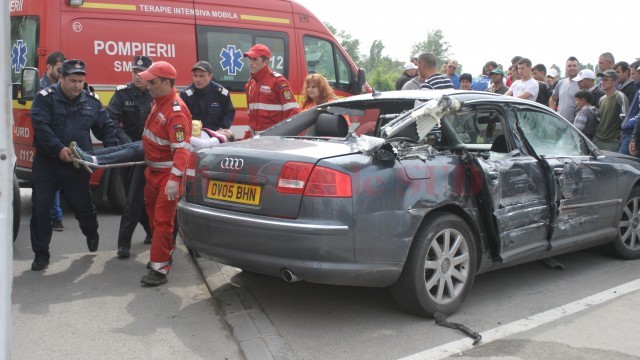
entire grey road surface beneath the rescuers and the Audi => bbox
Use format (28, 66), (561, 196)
(12, 190), (640, 360)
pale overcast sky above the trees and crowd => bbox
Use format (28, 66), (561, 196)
(296, 0), (640, 77)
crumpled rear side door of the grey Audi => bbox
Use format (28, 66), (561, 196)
(451, 106), (550, 263)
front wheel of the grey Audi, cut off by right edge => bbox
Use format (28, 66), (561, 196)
(610, 188), (640, 259)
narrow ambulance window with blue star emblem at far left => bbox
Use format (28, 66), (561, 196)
(11, 16), (42, 83)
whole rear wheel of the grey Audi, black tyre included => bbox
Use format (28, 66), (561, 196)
(391, 213), (477, 317)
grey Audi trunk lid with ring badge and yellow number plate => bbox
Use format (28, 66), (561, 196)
(184, 137), (358, 219)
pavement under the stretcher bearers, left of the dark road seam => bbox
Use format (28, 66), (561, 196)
(11, 189), (243, 360)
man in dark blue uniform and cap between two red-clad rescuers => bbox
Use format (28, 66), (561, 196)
(180, 61), (236, 130)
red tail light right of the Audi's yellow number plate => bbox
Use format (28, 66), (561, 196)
(276, 161), (352, 197)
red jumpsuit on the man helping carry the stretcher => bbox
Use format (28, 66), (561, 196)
(142, 91), (191, 275)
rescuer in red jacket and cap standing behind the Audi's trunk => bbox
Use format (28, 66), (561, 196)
(243, 44), (300, 138)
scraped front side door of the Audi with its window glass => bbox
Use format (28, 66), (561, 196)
(516, 107), (623, 250)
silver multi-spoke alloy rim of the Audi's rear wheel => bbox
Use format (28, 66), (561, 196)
(424, 229), (470, 305)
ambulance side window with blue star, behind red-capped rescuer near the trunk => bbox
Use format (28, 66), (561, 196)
(197, 26), (289, 91)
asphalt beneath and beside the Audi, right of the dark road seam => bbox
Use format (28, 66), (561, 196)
(216, 250), (640, 359)
